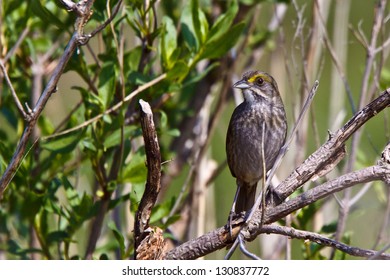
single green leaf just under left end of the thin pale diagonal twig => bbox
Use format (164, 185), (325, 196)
(41, 130), (84, 153)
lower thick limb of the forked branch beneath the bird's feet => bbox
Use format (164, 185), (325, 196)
(166, 165), (390, 259)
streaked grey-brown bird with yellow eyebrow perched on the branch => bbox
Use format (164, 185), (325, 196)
(226, 71), (287, 214)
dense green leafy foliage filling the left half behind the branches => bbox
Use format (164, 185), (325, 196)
(0, 0), (388, 259)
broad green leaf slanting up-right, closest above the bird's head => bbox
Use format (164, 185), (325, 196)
(199, 22), (245, 60)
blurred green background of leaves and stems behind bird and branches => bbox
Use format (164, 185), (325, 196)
(0, 0), (390, 259)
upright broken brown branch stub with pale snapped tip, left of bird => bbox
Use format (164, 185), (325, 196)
(134, 99), (161, 260)
